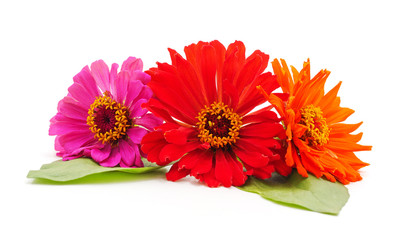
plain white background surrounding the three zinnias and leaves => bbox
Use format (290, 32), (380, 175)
(0, 0), (405, 239)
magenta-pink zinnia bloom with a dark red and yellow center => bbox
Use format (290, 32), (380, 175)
(49, 57), (162, 167)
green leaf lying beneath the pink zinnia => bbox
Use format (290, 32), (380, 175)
(27, 158), (161, 182)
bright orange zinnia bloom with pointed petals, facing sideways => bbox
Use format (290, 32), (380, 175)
(259, 59), (371, 184)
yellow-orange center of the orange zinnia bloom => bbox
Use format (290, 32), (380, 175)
(299, 104), (330, 146)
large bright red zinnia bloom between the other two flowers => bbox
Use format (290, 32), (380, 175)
(142, 41), (291, 187)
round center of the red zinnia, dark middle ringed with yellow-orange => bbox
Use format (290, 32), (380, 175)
(197, 102), (242, 148)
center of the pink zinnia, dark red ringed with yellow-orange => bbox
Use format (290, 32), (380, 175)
(87, 91), (132, 145)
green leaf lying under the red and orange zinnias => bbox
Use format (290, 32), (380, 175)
(238, 171), (349, 215)
